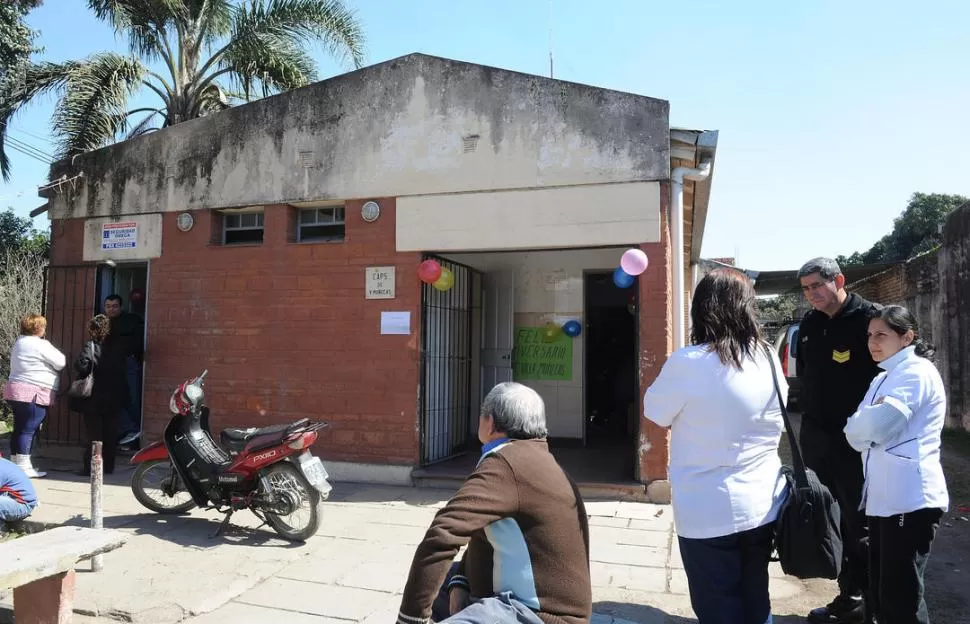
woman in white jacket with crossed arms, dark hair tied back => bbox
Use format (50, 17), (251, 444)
(845, 306), (950, 624)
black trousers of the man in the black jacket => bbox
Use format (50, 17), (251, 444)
(800, 417), (869, 596)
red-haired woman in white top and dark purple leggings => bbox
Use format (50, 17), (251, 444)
(3, 314), (67, 479)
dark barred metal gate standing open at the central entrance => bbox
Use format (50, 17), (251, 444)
(420, 256), (480, 466)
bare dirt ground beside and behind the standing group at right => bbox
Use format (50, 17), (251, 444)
(779, 414), (970, 624)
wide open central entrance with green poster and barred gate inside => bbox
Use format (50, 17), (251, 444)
(414, 248), (638, 491)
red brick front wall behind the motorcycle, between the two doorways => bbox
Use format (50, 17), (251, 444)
(49, 199), (421, 464)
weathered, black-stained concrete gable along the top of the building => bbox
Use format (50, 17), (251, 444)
(46, 54), (670, 219)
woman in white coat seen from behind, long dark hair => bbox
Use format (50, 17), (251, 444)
(643, 269), (788, 624)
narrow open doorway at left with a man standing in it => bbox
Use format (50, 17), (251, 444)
(95, 262), (148, 452)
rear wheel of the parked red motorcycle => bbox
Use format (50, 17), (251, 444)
(264, 462), (320, 542)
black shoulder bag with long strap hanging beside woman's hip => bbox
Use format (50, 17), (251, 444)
(765, 345), (842, 579)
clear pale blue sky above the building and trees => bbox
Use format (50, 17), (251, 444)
(0, 0), (970, 270)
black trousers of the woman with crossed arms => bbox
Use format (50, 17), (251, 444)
(869, 509), (943, 624)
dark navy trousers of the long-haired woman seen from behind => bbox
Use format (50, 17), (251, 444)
(677, 523), (775, 624)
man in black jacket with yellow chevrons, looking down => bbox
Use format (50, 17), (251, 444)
(795, 258), (879, 624)
